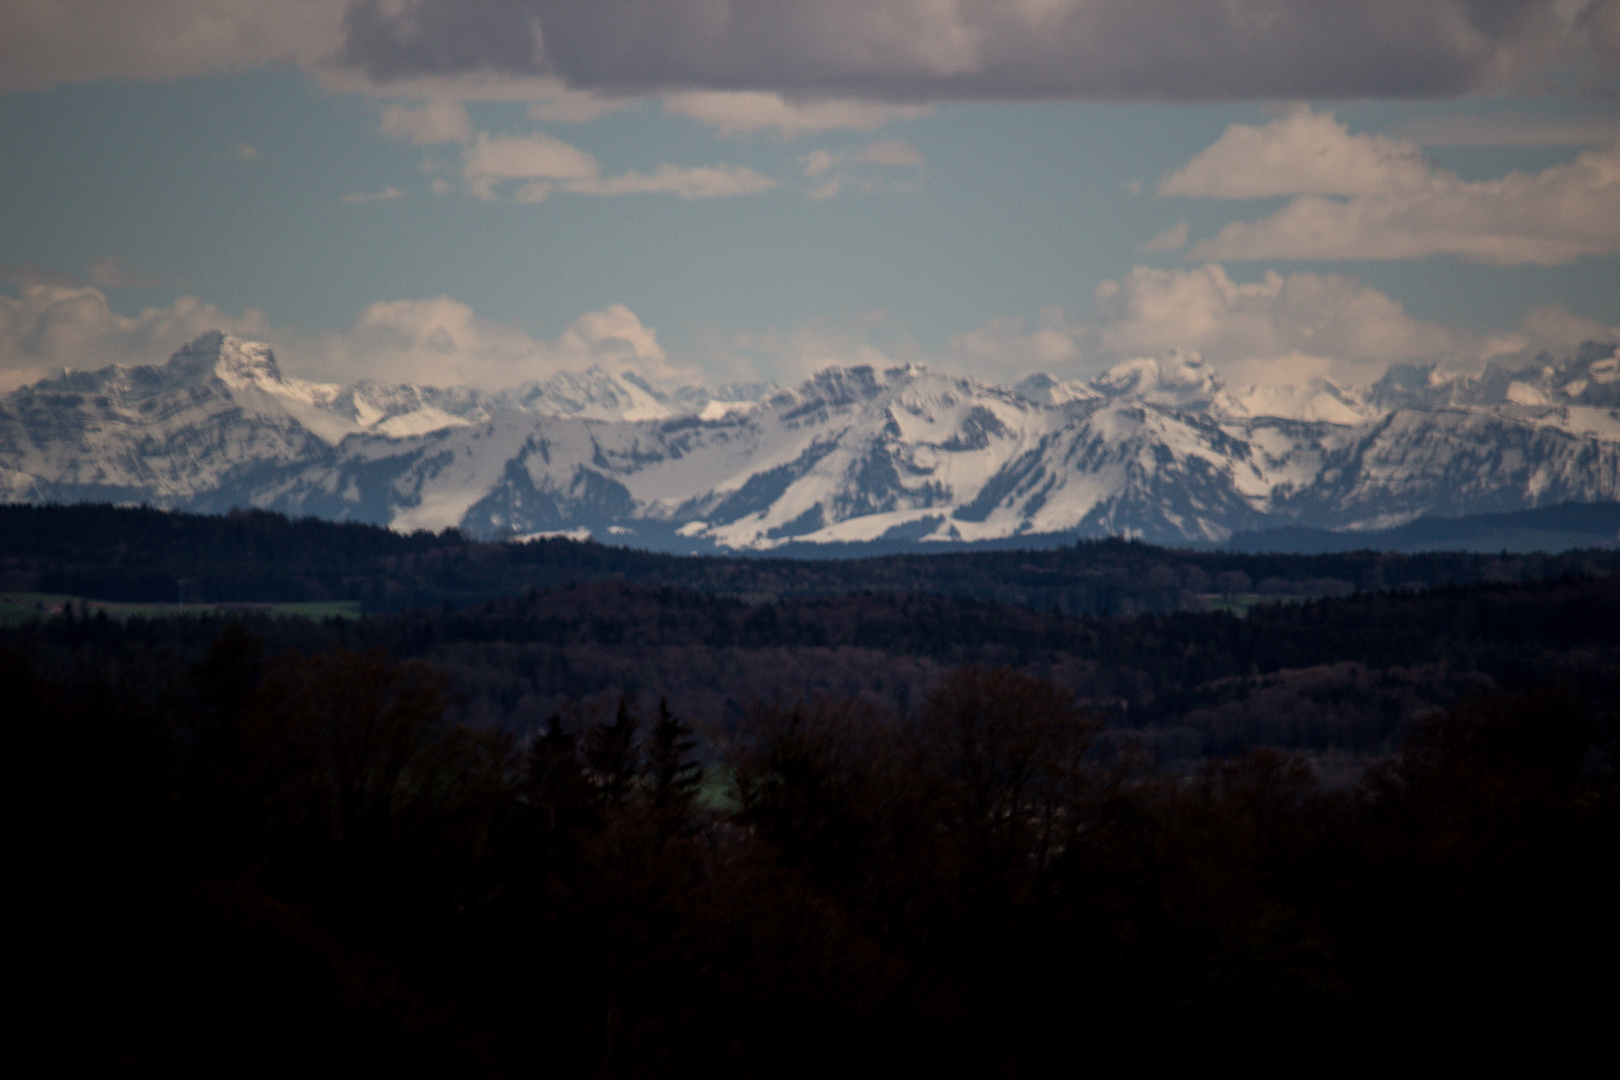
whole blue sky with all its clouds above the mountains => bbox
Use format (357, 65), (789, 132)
(0, 0), (1620, 390)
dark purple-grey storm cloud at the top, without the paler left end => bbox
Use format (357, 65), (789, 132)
(343, 0), (1594, 100)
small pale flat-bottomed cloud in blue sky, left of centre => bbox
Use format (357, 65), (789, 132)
(462, 131), (778, 202)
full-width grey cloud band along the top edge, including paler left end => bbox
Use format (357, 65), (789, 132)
(9, 0), (1620, 102)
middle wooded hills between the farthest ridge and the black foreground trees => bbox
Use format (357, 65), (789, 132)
(12, 576), (1620, 764)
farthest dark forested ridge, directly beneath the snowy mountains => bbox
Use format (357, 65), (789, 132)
(9, 504), (1620, 615)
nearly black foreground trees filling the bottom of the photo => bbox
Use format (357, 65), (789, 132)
(19, 627), (1620, 1077)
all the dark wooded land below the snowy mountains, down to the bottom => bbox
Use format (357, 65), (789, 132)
(0, 507), (1620, 1077)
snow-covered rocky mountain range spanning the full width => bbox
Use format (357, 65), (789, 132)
(0, 334), (1620, 551)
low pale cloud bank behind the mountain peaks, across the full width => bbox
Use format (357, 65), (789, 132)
(0, 266), (1620, 390)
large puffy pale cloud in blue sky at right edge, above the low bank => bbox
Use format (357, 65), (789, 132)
(1158, 108), (1620, 266)
